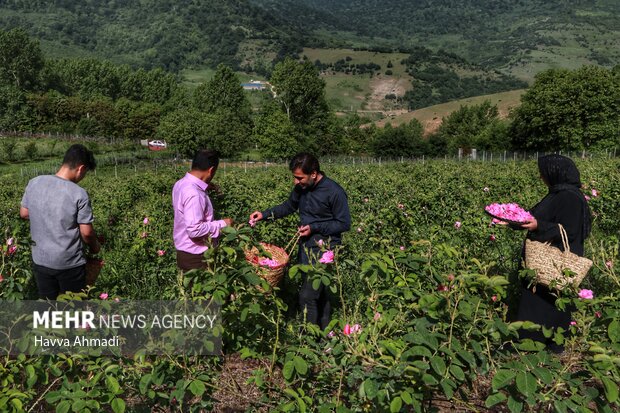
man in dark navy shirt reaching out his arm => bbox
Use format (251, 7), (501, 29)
(250, 153), (351, 329)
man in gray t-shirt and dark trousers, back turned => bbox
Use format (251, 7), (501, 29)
(19, 144), (100, 300)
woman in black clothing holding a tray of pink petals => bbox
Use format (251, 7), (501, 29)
(517, 155), (591, 353)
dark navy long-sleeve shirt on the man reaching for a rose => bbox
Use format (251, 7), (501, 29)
(262, 175), (351, 244)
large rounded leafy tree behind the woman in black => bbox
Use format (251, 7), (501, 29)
(510, 66), (620, 151)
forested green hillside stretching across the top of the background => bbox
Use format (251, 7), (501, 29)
(0, 0), (620, 75)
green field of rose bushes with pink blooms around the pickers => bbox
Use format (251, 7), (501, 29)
(0, 159), (620, 413)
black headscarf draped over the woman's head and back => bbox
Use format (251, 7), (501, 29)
(538, 154), (592, 238)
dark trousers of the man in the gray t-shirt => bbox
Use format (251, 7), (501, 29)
(32, 263), (86, 300)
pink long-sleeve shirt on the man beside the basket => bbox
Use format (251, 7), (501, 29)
(172, 173), (226, 254)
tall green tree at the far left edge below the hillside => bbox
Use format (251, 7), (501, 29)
(0, 29), (44, 90)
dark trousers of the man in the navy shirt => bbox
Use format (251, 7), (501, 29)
(297, 240), (332, 329)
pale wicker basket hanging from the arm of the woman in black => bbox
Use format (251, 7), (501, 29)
(525, 224), (592, 290)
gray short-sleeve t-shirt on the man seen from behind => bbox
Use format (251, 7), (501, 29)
(22, 175), (93, 270)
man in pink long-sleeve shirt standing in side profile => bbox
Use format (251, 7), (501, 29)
(172, 150), (232, 271)
